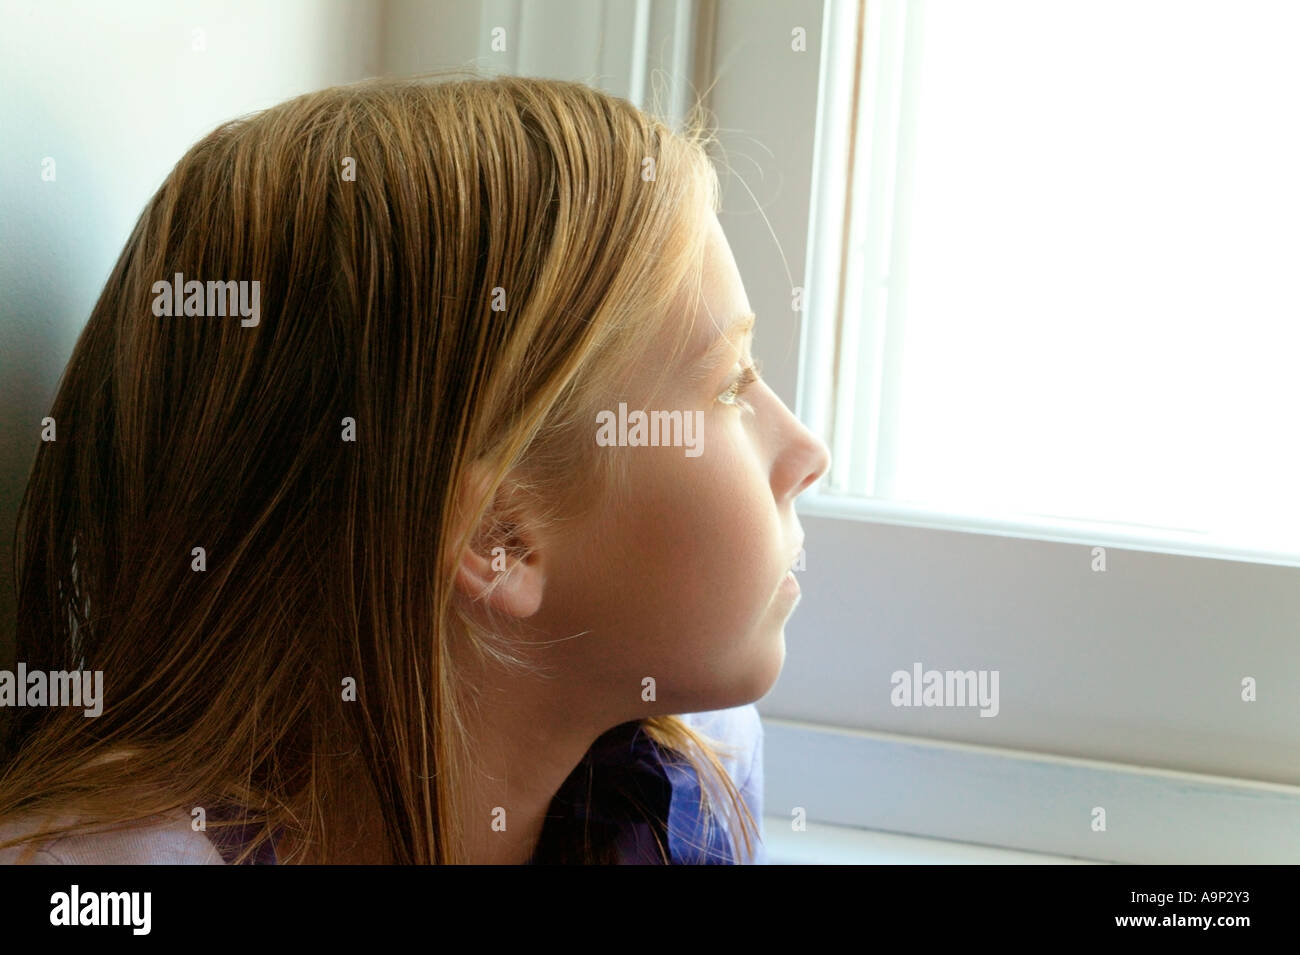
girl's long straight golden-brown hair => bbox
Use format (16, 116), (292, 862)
(0, 77), (754, 863)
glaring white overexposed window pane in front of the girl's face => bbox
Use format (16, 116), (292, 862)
(801, 0), (1300, 565)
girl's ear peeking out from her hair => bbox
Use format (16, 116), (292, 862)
(454, 468), (546, 617)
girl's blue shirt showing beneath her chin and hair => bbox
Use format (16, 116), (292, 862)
(208, 704), (767, 865)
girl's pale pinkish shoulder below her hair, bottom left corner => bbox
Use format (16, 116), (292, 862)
(0, 811), (225, 865)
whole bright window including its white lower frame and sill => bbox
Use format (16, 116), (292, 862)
(754, 0), (1300, 863)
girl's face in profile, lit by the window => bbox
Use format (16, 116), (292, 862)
(527, 210), (829, 721)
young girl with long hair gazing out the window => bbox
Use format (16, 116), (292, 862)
(0, 72), (828, 863)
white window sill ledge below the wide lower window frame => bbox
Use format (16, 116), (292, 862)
(763, 717), (1300, 865)
